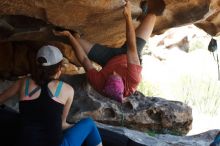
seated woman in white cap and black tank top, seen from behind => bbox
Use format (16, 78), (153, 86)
(0, 46), (102, 146)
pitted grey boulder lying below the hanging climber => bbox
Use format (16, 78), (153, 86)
(63, 75), (192, 135)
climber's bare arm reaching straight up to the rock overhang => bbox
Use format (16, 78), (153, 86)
(124, 0), (140, 65)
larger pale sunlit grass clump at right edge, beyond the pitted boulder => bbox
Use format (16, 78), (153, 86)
(173, 75), (220, 115)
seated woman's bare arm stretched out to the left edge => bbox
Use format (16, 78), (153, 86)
(0, 79), (22, 104)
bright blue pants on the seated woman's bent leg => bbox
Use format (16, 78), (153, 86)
(61, 118), (101, 146)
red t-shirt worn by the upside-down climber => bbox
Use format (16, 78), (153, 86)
(86, 54), (142, 97)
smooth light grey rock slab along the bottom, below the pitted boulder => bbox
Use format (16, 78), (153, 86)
(98, 124), (220, 146)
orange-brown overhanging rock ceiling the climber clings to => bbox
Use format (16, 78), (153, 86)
(0, 0), (220, 46)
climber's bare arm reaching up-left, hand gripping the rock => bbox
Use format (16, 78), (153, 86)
(54, 31), (94, 71)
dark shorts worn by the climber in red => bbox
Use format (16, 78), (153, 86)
(88, 37), (146, 66)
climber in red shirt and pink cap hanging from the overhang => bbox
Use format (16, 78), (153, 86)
(54, 0), (165, 102)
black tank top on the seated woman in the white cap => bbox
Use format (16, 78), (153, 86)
(19, 83), (64, 146)
